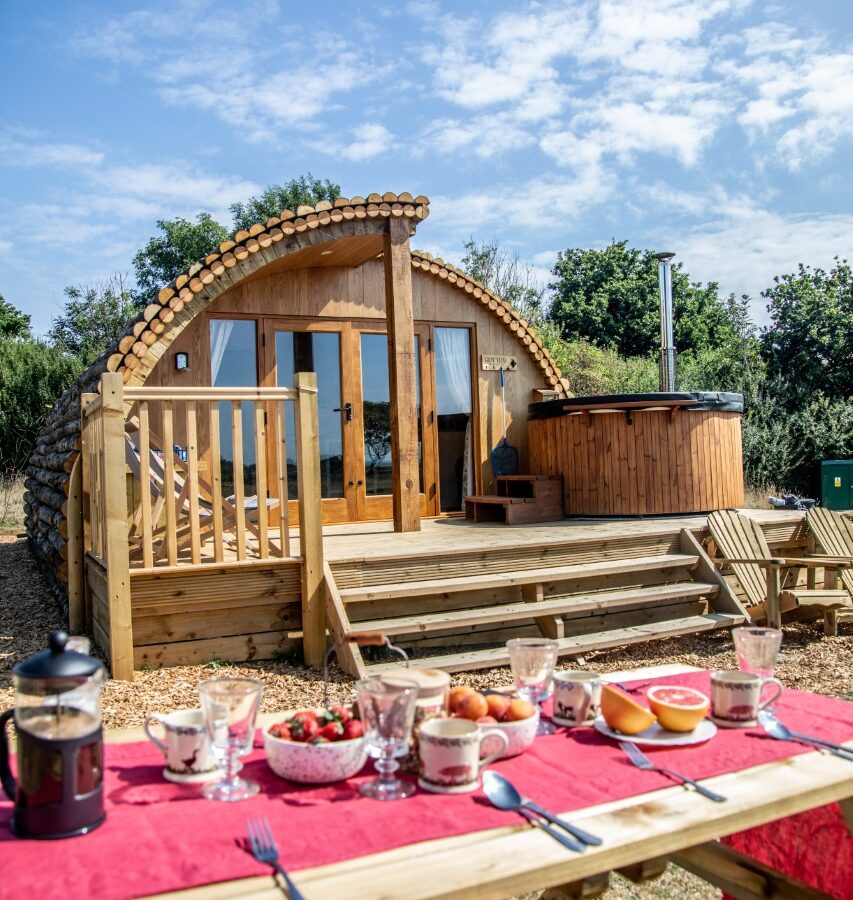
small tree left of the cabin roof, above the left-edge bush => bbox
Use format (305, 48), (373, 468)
(48, 275), (137, 365)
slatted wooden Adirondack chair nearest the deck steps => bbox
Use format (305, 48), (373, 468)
(708, 509), (853, 633)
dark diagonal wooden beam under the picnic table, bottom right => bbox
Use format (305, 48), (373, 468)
(671, 841), (826, 900)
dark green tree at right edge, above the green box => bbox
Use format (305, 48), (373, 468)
(761, 257), (853, 405)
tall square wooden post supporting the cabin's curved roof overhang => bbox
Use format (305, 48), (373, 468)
(383, 217), (421, 531)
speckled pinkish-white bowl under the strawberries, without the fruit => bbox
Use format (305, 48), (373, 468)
(264, 731), (367, 784)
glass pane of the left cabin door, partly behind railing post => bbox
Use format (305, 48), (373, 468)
(275, 331), (344, 500)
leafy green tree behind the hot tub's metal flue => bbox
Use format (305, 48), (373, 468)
(549, 241), (738, 356)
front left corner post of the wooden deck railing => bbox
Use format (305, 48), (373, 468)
(101, 372), (133, 681)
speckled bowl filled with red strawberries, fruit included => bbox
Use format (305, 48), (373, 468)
(264, 706), (367, 784)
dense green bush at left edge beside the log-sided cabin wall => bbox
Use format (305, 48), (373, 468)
(0, 337), (82, 474)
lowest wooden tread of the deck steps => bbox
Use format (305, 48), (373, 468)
(367, 613), (745, 675)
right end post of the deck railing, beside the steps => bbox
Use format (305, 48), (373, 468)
(295, 372), (326, 666)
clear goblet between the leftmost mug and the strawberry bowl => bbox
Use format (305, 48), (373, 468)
(198, 678), (264, 801)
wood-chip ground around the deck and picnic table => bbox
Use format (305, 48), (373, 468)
(0, 535), (853, 900)
